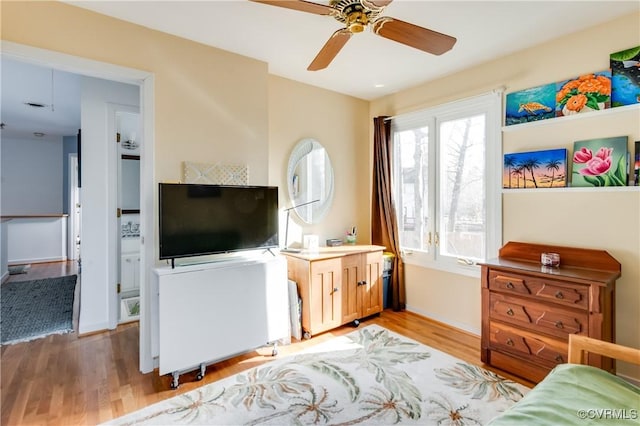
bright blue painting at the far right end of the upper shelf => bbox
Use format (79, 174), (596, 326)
(609, 46), (640, 107)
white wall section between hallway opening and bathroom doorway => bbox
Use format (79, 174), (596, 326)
(79, 77), (140, 334)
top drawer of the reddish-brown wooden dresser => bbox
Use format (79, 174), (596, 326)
(489, 271), (589, 310)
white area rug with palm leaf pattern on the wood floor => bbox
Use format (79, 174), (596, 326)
(108, 325), (528, 425)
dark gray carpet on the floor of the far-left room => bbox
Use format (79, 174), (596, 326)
(0, 275), (78, 345)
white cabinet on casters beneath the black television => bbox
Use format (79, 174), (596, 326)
(152, 252), (290, 388)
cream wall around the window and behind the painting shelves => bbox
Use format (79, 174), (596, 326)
(370, 14), (640, 379)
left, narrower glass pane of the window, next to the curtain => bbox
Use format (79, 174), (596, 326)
(394, 127), (429, 251)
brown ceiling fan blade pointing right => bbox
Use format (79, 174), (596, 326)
(373, 16), (457, 55)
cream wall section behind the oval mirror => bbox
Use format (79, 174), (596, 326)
(269, 76), (371, 245)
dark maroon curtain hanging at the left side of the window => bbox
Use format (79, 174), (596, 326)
(371, 117), (406, 311)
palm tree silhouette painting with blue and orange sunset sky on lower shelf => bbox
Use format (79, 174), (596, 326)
(502, 149), (567, 189)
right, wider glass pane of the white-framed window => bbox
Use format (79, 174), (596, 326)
(438, 115), (486, 259)
